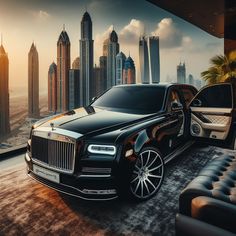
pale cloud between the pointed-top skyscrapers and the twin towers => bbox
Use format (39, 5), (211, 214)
(119, 19), (145, 44)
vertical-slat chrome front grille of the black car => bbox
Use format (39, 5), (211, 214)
(31, 135), (75, 173)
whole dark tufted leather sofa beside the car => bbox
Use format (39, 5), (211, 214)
(176, 155), (236, 236)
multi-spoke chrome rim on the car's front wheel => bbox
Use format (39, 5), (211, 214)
(130, 150), (164, 199)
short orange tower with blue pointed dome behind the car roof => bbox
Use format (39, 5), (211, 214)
(123, 56), (136, 84)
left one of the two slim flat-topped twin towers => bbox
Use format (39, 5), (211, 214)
(139, 37), (150, 84)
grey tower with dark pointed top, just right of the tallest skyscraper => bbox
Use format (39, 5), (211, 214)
(107, 30), (120, 89)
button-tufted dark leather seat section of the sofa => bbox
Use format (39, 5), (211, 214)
(179, 155), (236, 216)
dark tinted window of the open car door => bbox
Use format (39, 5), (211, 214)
(191, 84), (233, 108)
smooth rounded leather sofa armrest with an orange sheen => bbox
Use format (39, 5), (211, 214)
(191, 196), (236, 233)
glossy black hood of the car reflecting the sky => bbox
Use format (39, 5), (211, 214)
(36, 106), (150, 135)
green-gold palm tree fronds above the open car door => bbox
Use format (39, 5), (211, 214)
(201, 50), (236, 84)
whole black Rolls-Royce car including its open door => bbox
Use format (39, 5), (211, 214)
(25, 83), (236, 200)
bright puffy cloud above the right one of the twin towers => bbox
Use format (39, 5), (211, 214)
(151, 18), (183, 48)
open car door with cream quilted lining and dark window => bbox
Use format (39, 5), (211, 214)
(190, 83), (236, 149)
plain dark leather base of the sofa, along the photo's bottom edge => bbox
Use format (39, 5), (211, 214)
(175, 214), (235, 236)
